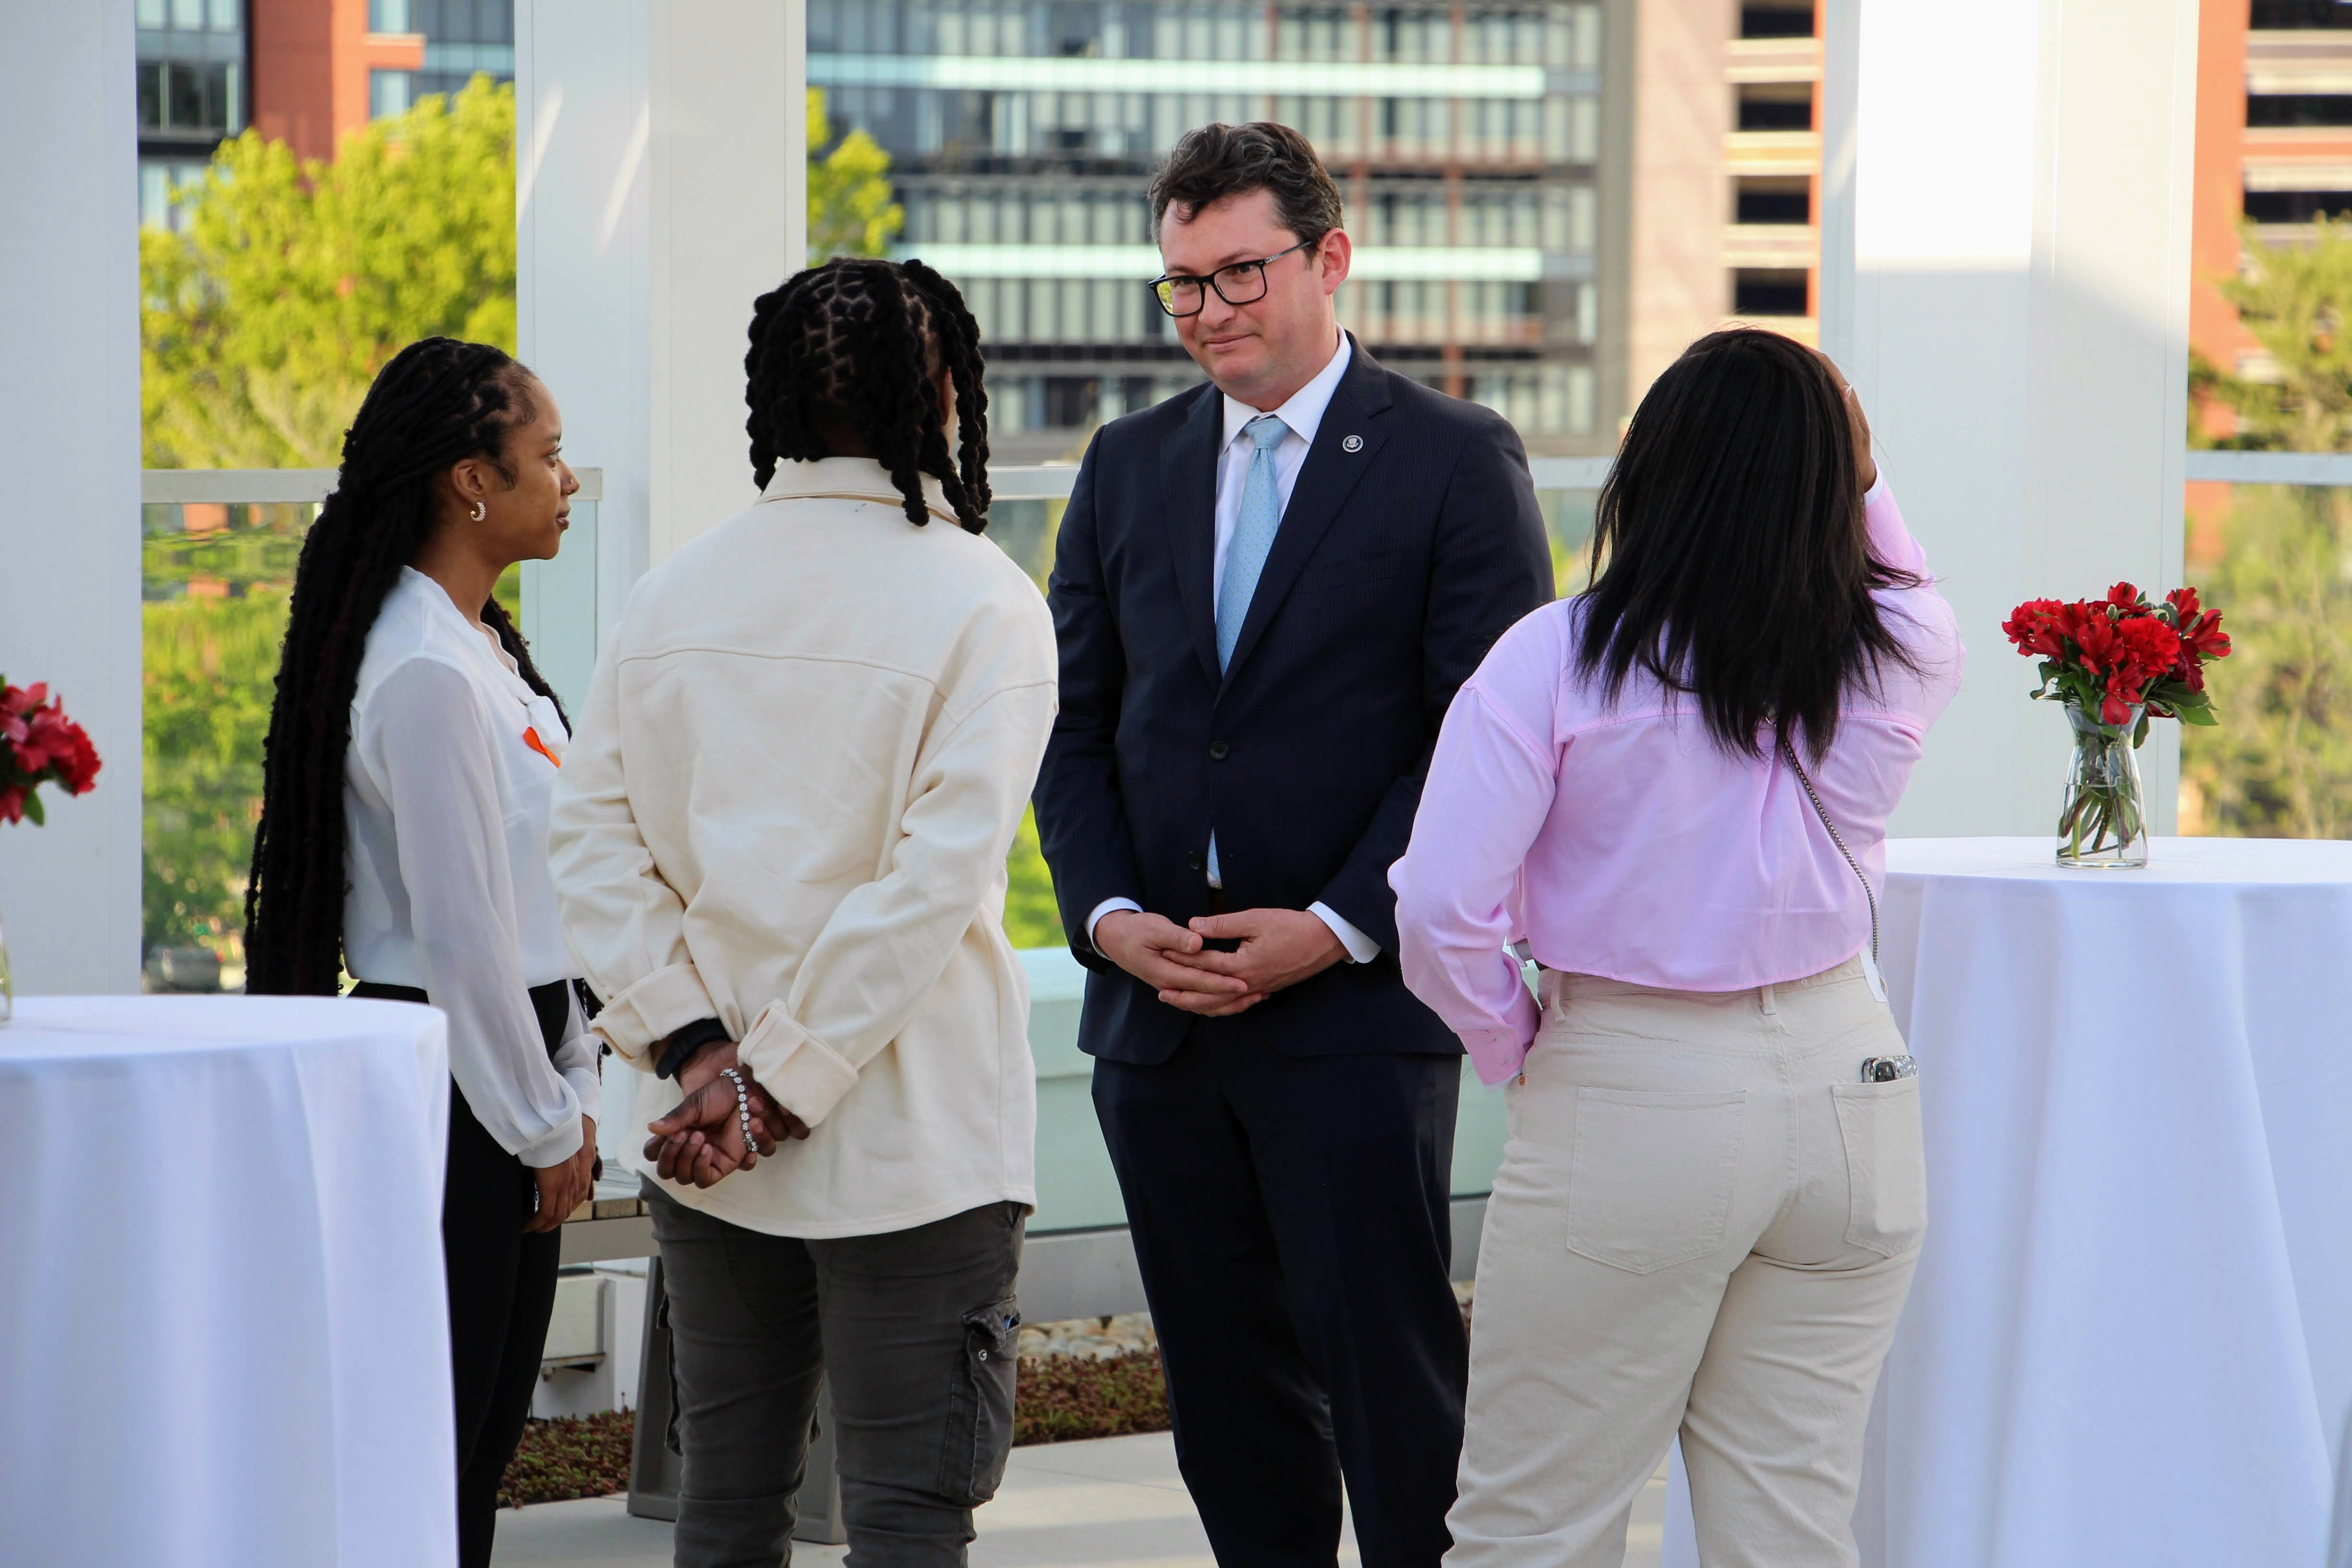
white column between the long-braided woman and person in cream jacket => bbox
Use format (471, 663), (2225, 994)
(515, 0), (807, 649)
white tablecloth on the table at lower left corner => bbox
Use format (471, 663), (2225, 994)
(0, 997), (456, 1568)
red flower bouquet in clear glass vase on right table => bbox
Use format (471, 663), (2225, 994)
(2001, 583), (2230, 867)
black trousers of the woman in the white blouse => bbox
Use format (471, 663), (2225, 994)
(351, 980), (571, 1568)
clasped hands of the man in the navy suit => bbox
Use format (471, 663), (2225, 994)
(1094, 910), (1348, 1018)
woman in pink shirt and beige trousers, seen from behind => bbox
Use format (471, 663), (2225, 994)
(1390, 329), (1962, 1568)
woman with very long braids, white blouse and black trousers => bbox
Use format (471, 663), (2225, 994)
(244, 339), (597, 1568)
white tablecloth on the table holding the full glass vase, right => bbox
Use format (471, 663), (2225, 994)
(1665, 839), (2352, 1568)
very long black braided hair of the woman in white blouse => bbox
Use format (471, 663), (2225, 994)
(244, 339), (555, 997)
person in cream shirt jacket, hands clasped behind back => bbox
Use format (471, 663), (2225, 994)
(550, 258), (1056, 1568)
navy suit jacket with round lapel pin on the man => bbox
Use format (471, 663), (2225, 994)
(1037, 346), (1552, 1063)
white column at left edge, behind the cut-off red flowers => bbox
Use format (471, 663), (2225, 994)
(0, 0), (139, 992)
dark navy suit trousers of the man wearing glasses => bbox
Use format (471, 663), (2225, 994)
(1094, 1022), (1470, 1568)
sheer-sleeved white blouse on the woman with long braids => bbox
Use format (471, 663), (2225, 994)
(343, 567), (597, 1166)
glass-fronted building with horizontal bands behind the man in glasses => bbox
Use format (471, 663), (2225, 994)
(809, 0), (1613, 461)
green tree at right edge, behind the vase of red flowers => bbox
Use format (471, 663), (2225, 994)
(2180, 219), (2352, 839)
